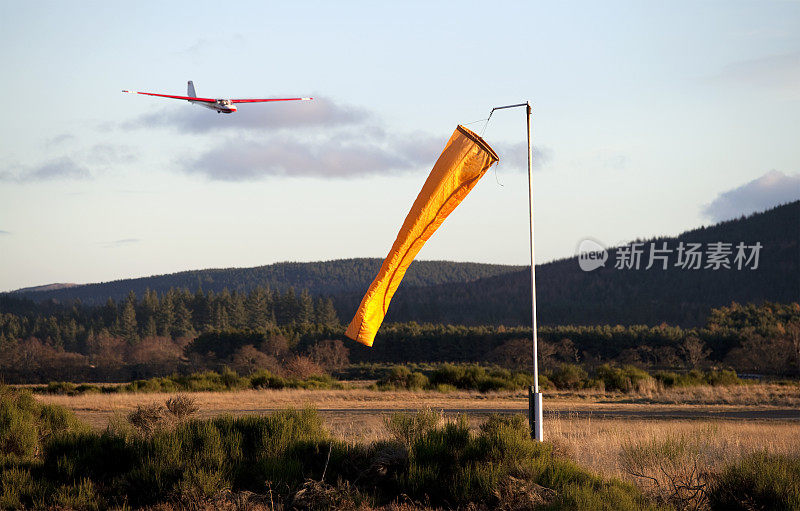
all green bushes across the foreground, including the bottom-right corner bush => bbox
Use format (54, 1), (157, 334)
(0, 387), (800, 510)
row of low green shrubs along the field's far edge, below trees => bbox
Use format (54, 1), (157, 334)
(31, 364), (745, 396)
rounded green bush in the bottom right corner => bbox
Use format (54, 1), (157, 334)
(708, 453), (800, 510)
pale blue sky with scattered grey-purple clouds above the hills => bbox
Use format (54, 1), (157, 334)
(0, 0), (800, 291)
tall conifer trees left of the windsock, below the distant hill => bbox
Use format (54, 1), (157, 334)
(0, 286), (339, 353)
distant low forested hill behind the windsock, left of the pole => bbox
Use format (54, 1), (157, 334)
(12, 258), (523, 305)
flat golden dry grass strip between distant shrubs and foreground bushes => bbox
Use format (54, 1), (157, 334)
(37, 384), (800, 429)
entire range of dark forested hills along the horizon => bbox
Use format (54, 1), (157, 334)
(11, 201), (800, 327)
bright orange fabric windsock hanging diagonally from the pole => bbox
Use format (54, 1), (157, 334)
(345, 125), (498, 346)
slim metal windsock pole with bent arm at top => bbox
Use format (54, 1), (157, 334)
(487, 102), (543, 442)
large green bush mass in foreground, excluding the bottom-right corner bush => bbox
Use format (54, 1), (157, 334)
(0, 389), (654, 509)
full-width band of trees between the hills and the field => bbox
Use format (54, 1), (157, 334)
(0, 287), (800, 382)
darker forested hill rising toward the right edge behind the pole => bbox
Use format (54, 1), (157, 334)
(370, 201), (800, 326)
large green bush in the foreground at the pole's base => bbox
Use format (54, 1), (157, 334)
(401, 416), (653, 510)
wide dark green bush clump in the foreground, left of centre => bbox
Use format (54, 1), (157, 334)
(44, 409), (338, 506)
